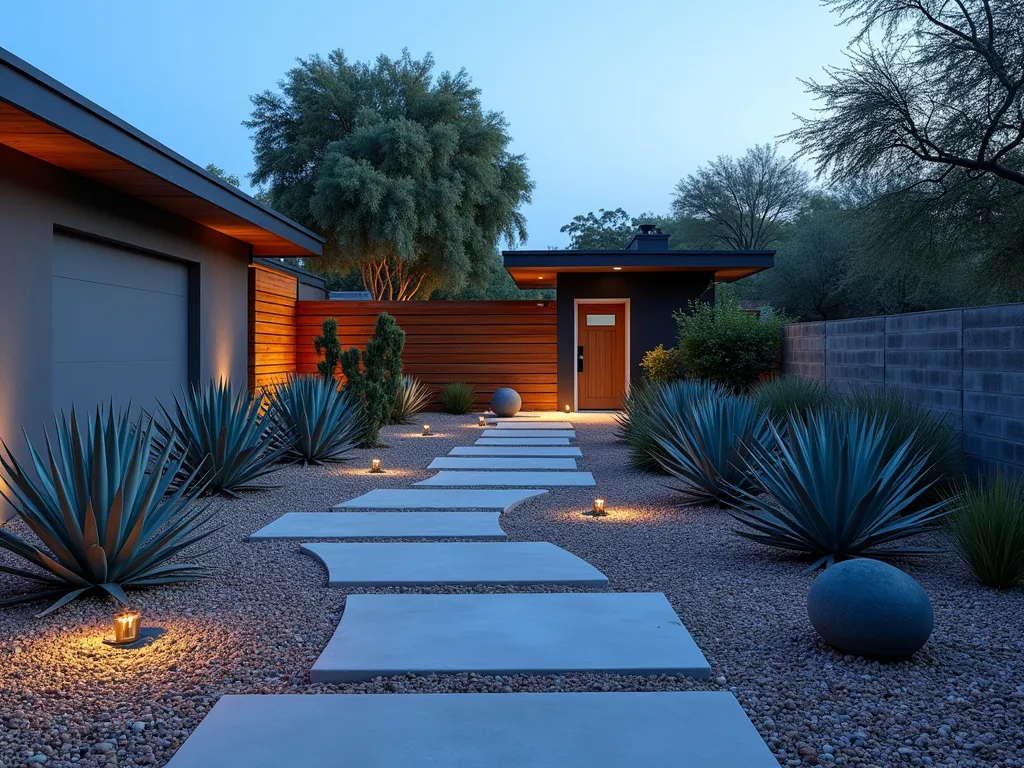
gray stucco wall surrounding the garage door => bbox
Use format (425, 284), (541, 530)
(0, 146), (250, 519)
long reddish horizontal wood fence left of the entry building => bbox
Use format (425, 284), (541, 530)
(294, 301), (557, 410)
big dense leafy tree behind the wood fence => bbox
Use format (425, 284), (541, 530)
(246, 50), (534, 300)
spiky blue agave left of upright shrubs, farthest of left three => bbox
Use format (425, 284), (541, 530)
(265, 375), (365, 464)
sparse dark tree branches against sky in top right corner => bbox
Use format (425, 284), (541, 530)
(790, 0), (1024, 191)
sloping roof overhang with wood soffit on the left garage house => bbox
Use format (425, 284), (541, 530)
(0, 48), (324, 256)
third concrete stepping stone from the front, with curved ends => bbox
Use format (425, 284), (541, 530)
(302, 540), (608, 587)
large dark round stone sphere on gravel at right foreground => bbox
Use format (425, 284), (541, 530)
(807, 558), (934, 660)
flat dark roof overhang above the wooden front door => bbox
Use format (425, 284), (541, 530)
(502, 251), (775, 288)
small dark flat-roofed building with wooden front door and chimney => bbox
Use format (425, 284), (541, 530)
(502, 224), (775, 411)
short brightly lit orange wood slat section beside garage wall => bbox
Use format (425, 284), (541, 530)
(249, 264), (299, 388)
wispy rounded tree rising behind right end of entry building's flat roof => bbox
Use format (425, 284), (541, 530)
(672, 144), (809, 251)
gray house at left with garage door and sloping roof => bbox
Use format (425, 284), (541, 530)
(0, 49), (324, 468)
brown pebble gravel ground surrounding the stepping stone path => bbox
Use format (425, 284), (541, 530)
(0, 414), (1024, 768)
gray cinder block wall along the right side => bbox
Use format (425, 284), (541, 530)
(782, 304), (1024, 473)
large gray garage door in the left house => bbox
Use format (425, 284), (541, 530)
(53, 234), (188, 412)
